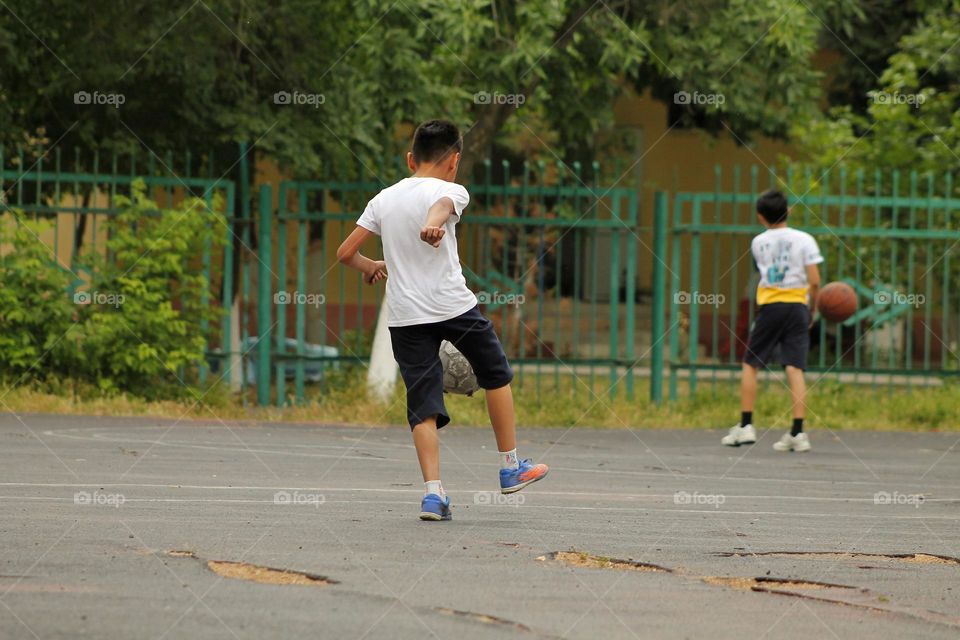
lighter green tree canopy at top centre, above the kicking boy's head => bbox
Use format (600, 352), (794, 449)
(350, 0), (857, 180)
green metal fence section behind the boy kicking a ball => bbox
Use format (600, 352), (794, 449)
(258, 161), (649, 405)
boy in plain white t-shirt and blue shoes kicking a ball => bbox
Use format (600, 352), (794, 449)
(337, 120), (548, 520)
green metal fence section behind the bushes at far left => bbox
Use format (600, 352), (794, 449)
(0, 147), (240, 382)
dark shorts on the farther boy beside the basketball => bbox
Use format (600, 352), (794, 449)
(743, 302), (810, 370)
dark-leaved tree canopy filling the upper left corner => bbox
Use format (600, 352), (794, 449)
(0, 0), (364, 177)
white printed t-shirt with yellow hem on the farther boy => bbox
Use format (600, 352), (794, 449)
(750, 227), (823, 304)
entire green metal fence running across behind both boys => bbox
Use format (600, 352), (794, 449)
(11, 149), (960, 405)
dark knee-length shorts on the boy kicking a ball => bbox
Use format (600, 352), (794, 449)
(390, 307), (513, 429)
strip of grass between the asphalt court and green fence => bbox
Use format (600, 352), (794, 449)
(0, 369), (960, 431)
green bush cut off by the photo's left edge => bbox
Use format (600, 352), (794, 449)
(0, 216), (73, 381)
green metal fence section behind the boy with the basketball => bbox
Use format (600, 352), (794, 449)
(655, 167), (960, 399)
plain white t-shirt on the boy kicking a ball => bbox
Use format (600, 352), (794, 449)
(357, 177), (477, 327)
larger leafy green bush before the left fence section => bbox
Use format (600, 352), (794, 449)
(71, 182), (226, 397)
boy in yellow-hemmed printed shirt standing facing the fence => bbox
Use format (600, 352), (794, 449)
(721, 191), (823, 451)
